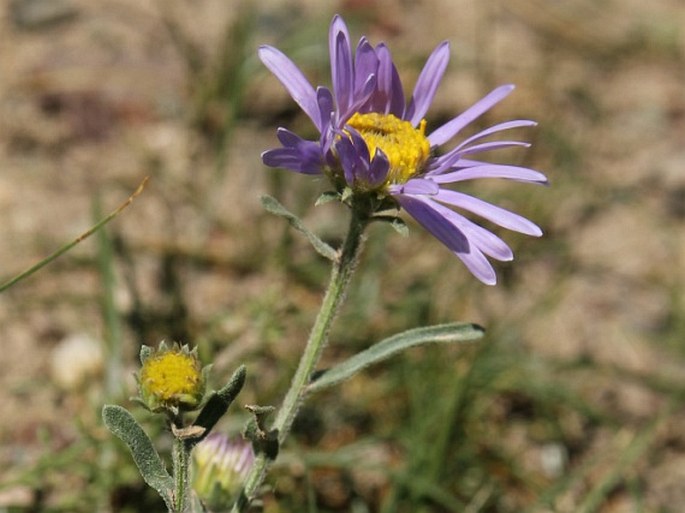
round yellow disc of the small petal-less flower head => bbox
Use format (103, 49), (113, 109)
(140, 351), (202, 402)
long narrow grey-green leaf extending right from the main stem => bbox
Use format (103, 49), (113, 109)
(308, 323), (485, 392)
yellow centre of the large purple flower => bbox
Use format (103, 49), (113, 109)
(347, 112), (430, 184)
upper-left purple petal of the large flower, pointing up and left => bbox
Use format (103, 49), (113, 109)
(259, 46), (321, 130)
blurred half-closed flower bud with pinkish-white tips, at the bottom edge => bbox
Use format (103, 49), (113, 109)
(193, 433), (254, 509)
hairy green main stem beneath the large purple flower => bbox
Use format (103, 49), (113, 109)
(232, 208), (367, 513)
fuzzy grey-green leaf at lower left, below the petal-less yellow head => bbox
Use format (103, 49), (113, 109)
(102, 405), (174, 510)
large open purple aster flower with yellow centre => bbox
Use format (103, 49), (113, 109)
(259, 15), (547, 285)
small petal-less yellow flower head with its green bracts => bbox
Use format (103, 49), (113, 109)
(137, 342), (205, 412)
